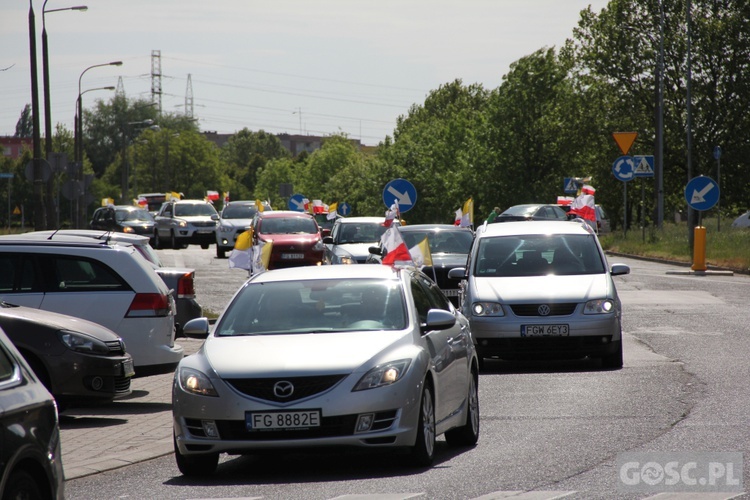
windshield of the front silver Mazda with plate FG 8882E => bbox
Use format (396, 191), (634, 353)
(216, 278), (406, 336)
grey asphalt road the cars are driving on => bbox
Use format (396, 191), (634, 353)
(66, 247), (750, 499)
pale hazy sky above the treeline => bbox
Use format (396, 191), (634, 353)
(0, 0), (608, 146)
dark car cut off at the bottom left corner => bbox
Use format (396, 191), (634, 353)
(0, 324), (65, 499)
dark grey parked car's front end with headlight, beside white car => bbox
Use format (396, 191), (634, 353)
(0, 302), (134, 409)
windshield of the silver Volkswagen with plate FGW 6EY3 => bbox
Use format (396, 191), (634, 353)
(474, 234), (605, 277)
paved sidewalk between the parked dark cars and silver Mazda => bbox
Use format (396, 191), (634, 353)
(60, 337), (203, 480)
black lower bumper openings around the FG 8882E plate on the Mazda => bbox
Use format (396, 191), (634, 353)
(185, 410), (398, 441)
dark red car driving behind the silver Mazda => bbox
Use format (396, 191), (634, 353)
(253, 210), (325, 270)
